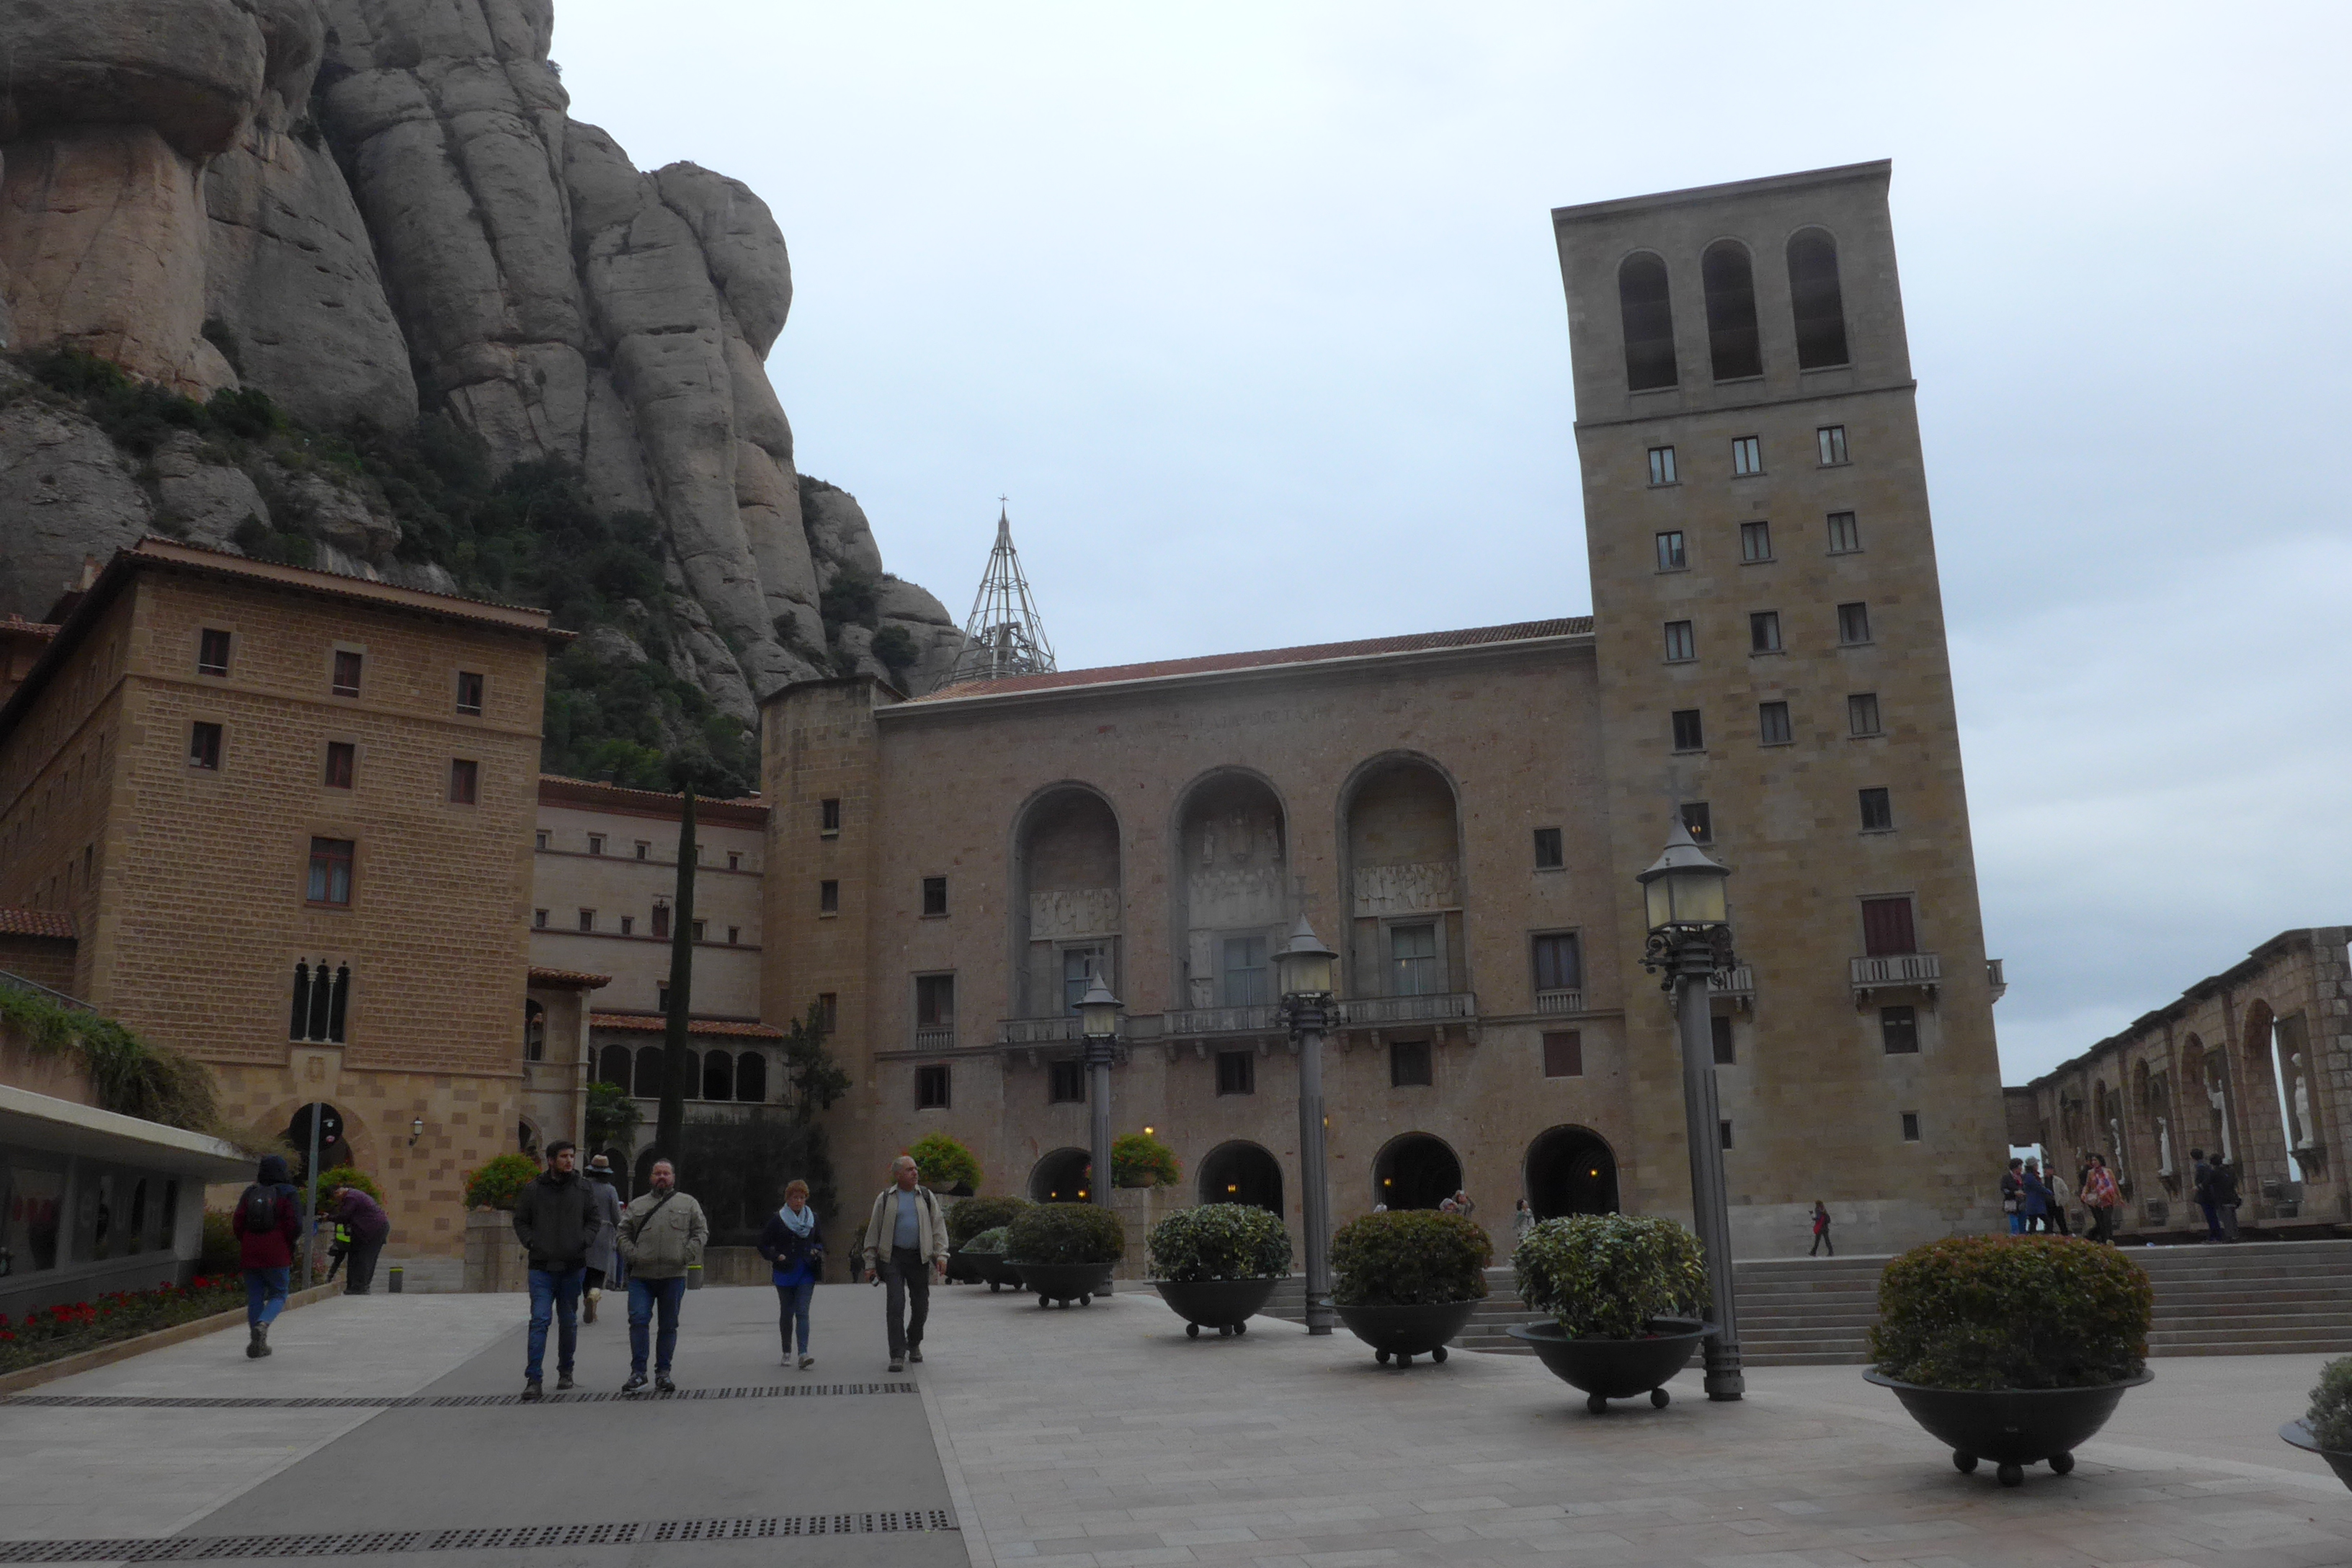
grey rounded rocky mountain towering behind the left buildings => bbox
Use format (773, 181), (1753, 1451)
(0, 0), (962, 724)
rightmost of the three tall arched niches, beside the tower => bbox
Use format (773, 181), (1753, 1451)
(1340, 754), (1468, 997)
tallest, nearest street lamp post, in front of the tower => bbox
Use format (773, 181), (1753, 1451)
(1639, 816), (1747, 1399)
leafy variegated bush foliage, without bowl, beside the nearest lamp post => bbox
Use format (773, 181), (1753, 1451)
(1510, 1213), (1708, 1340)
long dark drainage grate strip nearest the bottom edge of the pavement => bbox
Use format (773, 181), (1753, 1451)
(0, 1509), (957, 1563)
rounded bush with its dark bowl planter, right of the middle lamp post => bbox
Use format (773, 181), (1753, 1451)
(1331, 1208), (1494, 1371)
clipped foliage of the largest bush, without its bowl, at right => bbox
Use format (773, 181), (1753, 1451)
(1870, 1237), (2155, 1389)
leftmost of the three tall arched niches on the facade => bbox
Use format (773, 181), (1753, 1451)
(1012, 785), (1122, 1018)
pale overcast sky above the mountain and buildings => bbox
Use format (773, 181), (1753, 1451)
(555, 0), (2352, 1084)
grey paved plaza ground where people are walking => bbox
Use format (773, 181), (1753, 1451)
(0, 1286), (2352, 1568)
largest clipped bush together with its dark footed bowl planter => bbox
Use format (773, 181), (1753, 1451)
(1863, 1237), (2155, 1486)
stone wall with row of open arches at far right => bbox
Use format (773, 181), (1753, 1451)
(2008, 926), (2352, 1237)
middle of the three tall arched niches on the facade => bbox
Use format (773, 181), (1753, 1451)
(1169, 771), (1289, 1009)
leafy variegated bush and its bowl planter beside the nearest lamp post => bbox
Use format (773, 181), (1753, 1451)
(1507, 1213), (1714, 1415)
